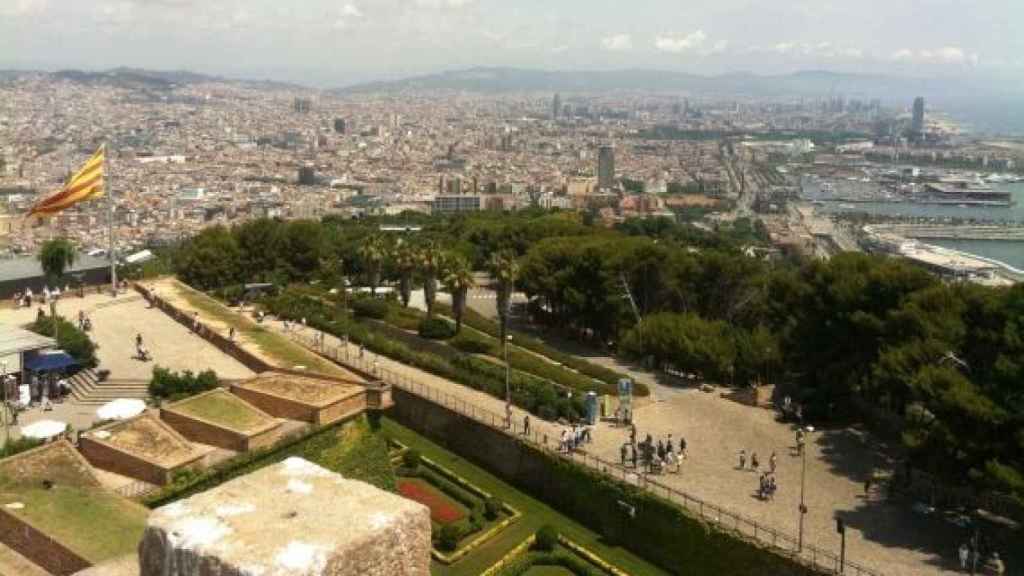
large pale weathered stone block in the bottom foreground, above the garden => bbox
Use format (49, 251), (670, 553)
(139, 458), (430, 576)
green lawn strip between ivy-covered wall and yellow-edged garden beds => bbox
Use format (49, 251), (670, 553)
(381, 418), (668, 576)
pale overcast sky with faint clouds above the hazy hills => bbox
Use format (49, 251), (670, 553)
(0, 0), (1024, 85)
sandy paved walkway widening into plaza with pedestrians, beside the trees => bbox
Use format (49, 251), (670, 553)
(280, 301), (966, 576)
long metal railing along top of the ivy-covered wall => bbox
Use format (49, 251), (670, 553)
(288, 332), (883, 576)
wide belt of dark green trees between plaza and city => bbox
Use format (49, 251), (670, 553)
(175, 211), (1024, 494)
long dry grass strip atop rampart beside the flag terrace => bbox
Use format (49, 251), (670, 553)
(171, 282), (350, 378)
